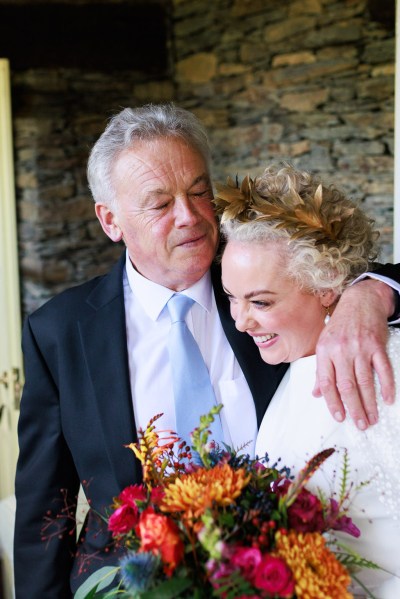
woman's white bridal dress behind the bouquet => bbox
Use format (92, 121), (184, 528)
(256, 329), (400, 599)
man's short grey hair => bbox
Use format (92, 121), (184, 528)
(87, 103), (211, 209)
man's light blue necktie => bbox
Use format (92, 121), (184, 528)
(167, 294), (224, 445)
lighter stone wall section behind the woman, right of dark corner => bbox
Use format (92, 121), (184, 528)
(174, 0), (395, 255)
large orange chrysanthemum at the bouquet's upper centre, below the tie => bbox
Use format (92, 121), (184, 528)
(161, 464), (250, 520)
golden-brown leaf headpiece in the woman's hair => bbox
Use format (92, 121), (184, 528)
(214, 176), (355, 244)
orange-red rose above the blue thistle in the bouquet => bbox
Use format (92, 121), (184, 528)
(135, 508), (184, 576)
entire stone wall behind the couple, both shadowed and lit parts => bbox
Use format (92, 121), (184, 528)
(5, 0), (395, 313)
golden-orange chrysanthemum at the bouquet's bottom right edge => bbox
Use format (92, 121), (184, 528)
(276, 531), (353, 599)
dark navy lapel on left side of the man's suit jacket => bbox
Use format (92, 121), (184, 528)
(79, 252), (141, 488)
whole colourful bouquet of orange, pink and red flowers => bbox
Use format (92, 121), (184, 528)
(75, 407), (374, 599)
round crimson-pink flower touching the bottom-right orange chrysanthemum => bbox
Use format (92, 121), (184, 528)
(253, 555), (294, 597)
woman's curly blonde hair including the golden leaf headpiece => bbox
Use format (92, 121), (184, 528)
(214, 164), (379, 295)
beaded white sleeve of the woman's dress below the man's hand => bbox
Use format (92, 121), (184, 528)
(347, 328), (400, 519)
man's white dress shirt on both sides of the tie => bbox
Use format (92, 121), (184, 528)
(124, 253), (257, 455)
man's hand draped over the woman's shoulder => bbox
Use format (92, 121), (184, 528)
(313, 279), (395, 430)
